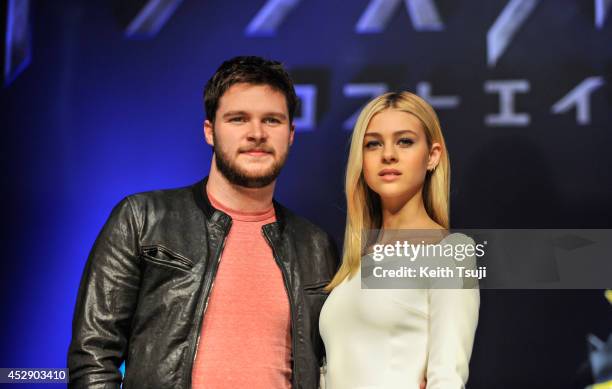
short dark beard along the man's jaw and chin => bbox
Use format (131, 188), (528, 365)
(213, 133), (288, 188)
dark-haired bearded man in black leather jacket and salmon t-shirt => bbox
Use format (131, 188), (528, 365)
(68, 57), (338, 389)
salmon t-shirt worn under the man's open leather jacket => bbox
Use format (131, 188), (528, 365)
(192, 189), (291, 389)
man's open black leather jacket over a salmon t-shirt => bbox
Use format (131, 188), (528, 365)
(68, 179), (338, 389)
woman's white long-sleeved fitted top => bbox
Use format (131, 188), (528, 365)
(319, 234), (480, 389)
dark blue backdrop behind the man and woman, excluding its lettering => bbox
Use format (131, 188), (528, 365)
(0, 0), (612, 389)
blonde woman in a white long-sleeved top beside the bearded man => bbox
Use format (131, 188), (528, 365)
(319, 92), (480, 389)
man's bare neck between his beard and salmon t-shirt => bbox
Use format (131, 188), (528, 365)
(206, 160), (276, 212)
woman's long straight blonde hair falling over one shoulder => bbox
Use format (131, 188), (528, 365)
(326, 92), (450, 291)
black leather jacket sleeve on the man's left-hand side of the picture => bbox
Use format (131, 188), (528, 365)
(68, 197), (142, 389)
